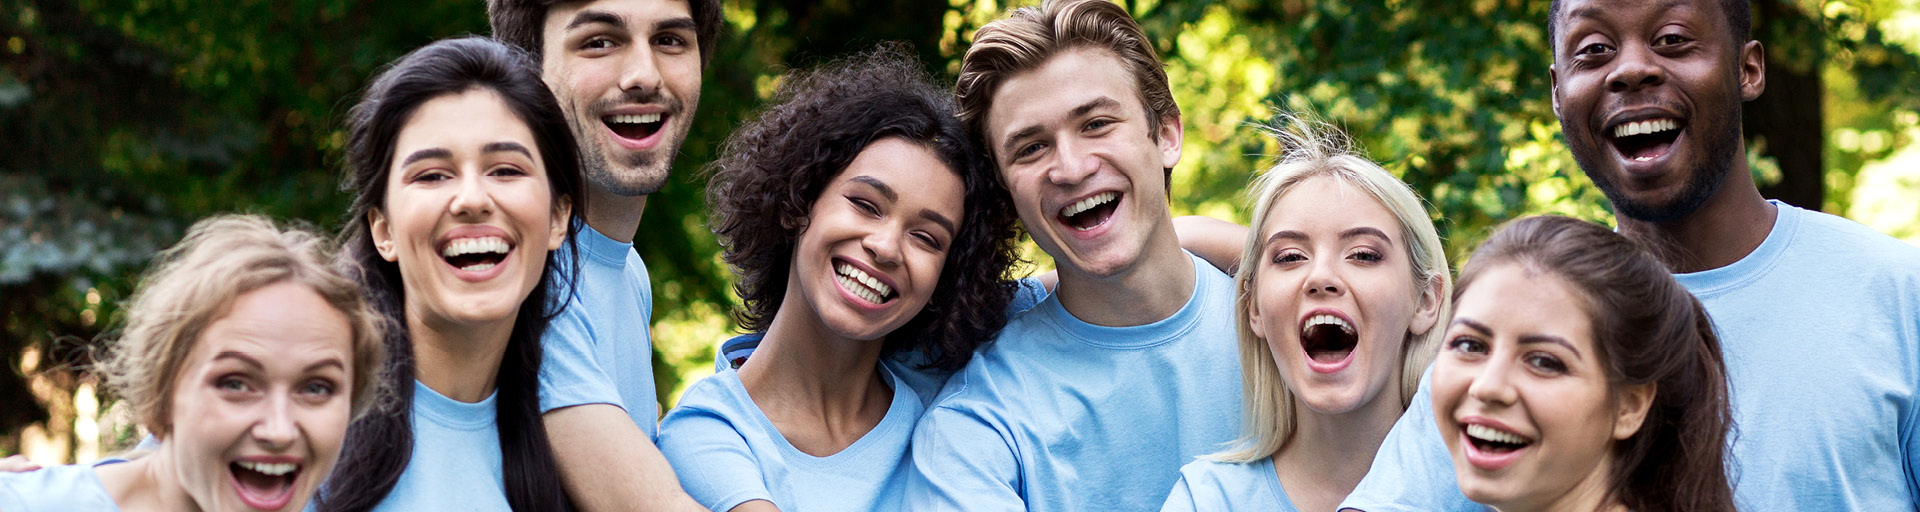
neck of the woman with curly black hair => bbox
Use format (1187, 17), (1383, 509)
(739, 301), (900, 456)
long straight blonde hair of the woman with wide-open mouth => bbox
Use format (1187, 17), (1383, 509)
(1208, 113), (1453, 462)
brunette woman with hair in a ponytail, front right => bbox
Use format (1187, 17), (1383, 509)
(1432, 217), (1734, 512)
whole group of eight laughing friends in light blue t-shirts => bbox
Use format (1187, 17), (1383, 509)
(0, 0), (1920, 512)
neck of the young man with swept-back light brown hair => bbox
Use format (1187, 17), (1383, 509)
(1054, 231), (1198, 328)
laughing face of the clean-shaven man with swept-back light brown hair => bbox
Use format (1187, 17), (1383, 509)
(987, 48), (1181, 278)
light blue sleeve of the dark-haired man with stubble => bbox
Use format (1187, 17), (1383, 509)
(540, 301), (625, 414)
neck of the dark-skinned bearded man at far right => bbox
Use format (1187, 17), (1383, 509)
(1619, 157), (1780, 274)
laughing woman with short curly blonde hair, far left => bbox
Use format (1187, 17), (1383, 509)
(0, 215), (382, 512)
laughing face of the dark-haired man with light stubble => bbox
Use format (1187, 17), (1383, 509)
(541, 0), (701, 196)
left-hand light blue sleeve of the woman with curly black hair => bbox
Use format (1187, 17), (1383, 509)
(660, 407), (778, 510)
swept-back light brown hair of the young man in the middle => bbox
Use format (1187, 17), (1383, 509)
(954, 0), (1181, 161)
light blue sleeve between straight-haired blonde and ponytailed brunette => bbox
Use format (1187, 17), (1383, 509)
(1340, 366), (1486, 512)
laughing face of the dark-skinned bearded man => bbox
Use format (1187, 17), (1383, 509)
(1553, 0), (1764, 222)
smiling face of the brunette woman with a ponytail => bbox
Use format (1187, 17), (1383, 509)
(1432, 263), (1649, 510)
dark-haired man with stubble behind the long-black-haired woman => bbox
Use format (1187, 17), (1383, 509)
(488, 0), (722, 510)
